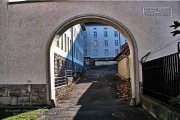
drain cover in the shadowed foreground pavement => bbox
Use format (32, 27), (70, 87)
(112, 112), (134, 120)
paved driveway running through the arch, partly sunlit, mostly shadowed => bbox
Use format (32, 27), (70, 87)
(40, 66), (154, 120)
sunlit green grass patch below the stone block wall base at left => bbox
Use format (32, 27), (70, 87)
(2, 108), (45, 120)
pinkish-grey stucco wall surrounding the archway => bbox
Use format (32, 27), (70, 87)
(0, 1), (180, 84)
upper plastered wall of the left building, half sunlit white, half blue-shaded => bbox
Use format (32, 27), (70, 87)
(53, 24), (84, 66)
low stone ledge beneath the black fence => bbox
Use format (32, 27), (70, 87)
(141, 95), (180, 120)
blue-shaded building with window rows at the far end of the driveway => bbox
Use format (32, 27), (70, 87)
(84, 23), (125, 65)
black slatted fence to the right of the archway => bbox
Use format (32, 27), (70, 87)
(142, 53), (180, 104)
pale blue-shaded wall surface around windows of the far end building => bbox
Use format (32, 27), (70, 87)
(84, 25), (125, 58)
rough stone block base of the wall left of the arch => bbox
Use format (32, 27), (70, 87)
(0, 84), (47, 106)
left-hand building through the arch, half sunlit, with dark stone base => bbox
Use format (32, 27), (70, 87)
(53, 24), (85, 77)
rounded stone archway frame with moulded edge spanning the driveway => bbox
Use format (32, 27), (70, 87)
(46, 14), (140, 104)
